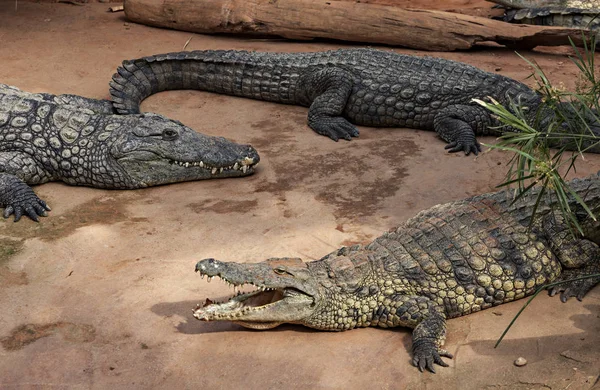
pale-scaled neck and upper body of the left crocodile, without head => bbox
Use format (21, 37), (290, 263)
(0, 96), (135, 188)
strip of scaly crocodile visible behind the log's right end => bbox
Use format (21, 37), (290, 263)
(502, 7), (600, 30)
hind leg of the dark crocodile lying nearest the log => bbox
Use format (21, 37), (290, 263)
(301, 67), (358, 141)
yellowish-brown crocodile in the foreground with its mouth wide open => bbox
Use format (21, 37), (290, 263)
(194, 175), (600, 372)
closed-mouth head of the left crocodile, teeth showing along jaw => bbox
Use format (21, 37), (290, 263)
(110, 114), (260, 187)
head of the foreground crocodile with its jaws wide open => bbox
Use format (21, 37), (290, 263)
(194, 258), (322, 329)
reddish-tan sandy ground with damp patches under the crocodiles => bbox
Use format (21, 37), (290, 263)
(0, 0), (600, 390)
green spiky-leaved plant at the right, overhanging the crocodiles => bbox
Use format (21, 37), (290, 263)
(473, 37), (600, 234)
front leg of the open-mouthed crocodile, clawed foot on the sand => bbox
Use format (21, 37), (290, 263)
(396, 295), (452, 373)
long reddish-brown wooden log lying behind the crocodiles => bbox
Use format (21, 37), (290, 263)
(124, 0), (582, 51)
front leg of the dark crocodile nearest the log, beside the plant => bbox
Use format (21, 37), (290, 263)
(433, 104), (491, 156)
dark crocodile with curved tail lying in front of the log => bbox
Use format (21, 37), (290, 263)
(110, 49), (600, 155)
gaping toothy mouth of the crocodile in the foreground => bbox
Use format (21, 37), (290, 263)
(193, 269), (313, 329)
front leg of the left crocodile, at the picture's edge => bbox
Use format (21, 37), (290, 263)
(0, 152), (50, 222)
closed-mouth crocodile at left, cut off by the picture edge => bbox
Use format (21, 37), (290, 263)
(0, 84), (259, 221)
